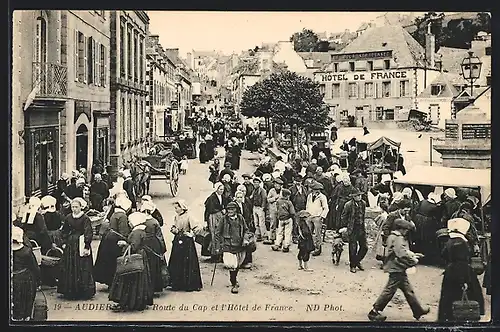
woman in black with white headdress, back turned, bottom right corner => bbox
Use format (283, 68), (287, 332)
(438, 218), (484, 322)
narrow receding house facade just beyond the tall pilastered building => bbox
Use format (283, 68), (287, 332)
(146, 35), (176, 140)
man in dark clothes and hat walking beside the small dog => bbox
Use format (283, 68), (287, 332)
(340, 189), (368, 273)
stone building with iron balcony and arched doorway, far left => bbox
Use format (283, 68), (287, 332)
(11, 10), (110, 207)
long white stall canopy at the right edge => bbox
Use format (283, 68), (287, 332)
(394, 166), (491, 205)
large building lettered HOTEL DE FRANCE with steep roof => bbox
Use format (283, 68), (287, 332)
(314, 26), (440, 126)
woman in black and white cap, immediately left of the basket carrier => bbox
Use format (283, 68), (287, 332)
(94, 196), (132, 287)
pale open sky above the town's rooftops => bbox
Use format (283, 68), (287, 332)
(148, 11), (402, 57)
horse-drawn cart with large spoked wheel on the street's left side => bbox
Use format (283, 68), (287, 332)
(141, 137), (179, 197)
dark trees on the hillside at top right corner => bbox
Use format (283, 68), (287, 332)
(412, 12), (491, 50)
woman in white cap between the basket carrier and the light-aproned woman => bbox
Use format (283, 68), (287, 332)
(141, 201), (167, 292)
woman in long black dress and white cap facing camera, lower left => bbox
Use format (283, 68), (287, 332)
(57, 197), (96, 300)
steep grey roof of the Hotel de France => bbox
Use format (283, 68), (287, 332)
(341, 25), (425, 67)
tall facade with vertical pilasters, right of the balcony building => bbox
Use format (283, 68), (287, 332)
(110, 10), (149, 169)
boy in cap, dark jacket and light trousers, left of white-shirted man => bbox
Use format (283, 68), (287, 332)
(271, 189), (295, 252)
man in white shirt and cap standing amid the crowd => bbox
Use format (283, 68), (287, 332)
(306, 182), (329, 256)
